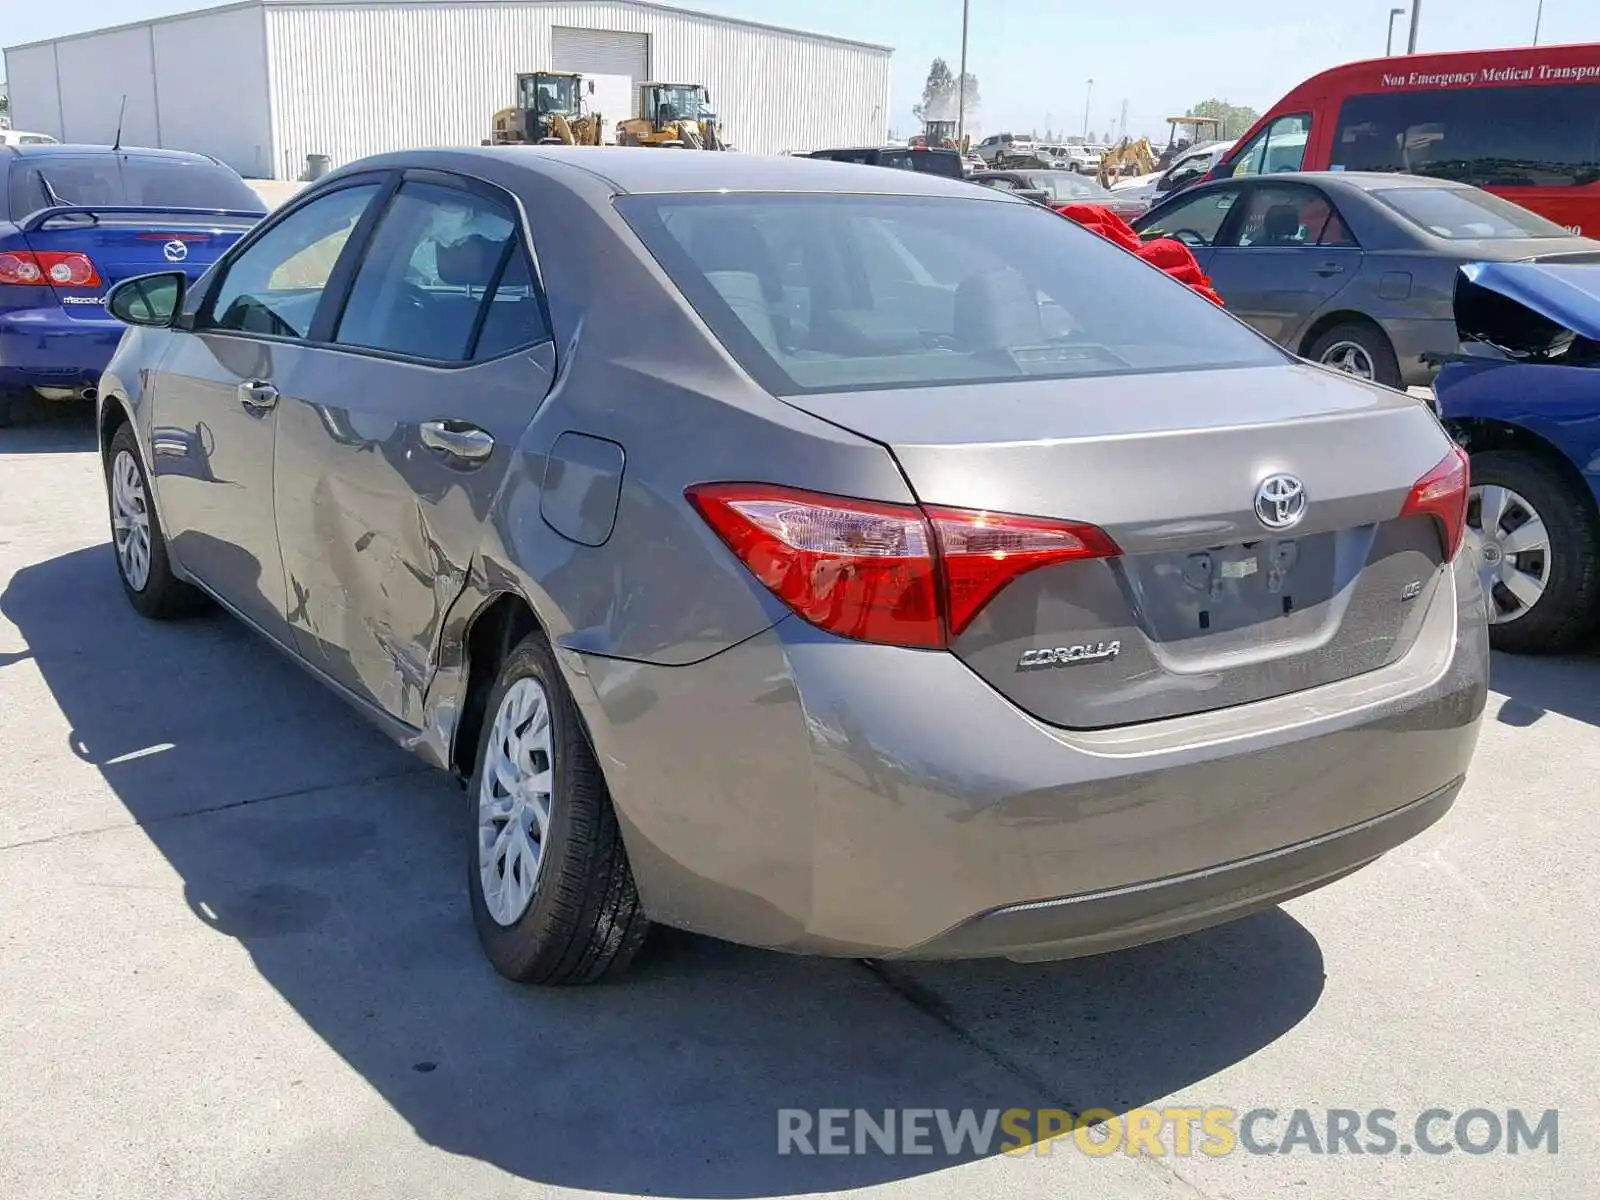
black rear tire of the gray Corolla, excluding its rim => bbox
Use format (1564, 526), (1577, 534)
(467, 634), (650, 986)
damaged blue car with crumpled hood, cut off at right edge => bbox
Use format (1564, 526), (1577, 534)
(1434, 262), (1600, 654)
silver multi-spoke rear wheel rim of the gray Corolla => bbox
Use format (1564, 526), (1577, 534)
(478, 678), (555, 925)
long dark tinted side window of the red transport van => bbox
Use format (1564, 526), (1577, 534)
(1330, 83), (1600, 187)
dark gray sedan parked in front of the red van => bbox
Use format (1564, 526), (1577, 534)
(1133, 171), (1600, 387)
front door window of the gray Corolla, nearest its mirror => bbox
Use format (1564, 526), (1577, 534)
(198, 184), (379, 338)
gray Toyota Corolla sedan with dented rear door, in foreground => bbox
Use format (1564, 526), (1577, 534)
(99, 147), (1488, 984)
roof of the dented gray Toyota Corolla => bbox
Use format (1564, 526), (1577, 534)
(334, 146), (992, 198)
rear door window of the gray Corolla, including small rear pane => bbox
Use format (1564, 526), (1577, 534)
(334, 184), (542, 362)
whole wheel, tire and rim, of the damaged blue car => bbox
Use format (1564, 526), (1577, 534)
(1467, 450), (1600, 654)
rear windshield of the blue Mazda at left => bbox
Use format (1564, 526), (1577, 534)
(10, 150), (266, 219)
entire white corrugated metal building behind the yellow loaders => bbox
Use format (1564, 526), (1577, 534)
(5, 0), (890, 179)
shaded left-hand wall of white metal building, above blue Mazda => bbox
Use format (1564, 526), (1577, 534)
(5, 5), (272, 176)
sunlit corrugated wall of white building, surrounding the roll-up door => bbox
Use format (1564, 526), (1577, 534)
(266, 0), (890, 178)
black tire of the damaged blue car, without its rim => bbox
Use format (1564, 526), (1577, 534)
(1472, 450), (1600, 654)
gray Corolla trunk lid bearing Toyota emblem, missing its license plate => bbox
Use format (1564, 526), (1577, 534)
(789, 365), (1450, 728)
